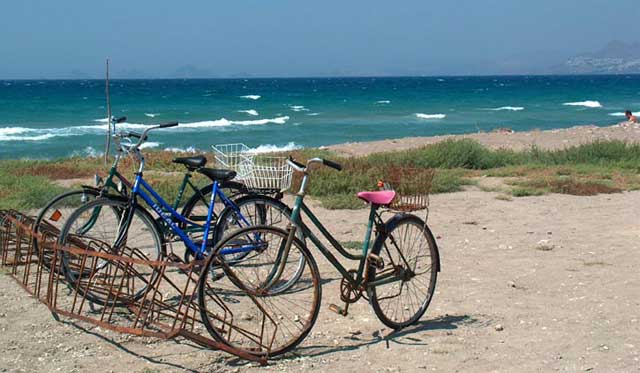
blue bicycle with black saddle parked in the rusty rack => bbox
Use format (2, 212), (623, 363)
(58, 123), (305, 305)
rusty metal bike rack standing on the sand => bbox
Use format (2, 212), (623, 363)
(0, 210), (268, 365)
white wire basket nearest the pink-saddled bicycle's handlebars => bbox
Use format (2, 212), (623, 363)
(238, 155), (293, 191)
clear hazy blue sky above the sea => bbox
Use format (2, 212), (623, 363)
(0, 0), (640, 79)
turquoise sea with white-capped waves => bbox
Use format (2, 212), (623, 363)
(0, 75), (640, 158)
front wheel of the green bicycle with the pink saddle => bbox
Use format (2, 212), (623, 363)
(198, 226), (322, 356)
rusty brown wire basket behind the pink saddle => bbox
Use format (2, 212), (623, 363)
(384, 167), (435, 212)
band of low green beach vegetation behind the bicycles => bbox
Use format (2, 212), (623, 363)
(0, 139), (640, 209)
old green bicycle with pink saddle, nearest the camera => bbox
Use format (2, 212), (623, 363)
(199, 157), (440, 356)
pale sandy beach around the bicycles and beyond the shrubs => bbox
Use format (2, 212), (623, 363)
(0, 126), (640, 372)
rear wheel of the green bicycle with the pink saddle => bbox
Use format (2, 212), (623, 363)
(368, 215), (439, 329)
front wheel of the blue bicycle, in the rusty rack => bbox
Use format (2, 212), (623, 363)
(58, 198), (165, 305)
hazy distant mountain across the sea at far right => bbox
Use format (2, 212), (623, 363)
(553, 41), (640, 74)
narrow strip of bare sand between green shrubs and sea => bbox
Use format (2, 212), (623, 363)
(328, 122), (640, 157)
